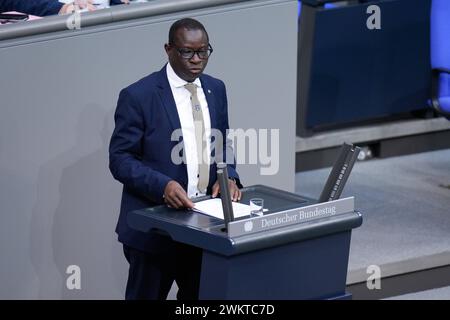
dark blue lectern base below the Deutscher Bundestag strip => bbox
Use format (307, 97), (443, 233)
(199, 231), (351, 300)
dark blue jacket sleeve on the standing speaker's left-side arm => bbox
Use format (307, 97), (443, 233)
(109, 89), (171, 202)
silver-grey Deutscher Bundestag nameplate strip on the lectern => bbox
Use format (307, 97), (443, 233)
(228, 197), (355, 237)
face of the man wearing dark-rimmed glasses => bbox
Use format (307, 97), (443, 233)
(164, 28), (208, 82)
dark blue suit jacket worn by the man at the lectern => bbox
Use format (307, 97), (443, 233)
(109, 67), (239, 252)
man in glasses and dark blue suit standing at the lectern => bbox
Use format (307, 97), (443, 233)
(109, 18), (242, 300)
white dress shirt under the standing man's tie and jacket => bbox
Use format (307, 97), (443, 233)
(166, 63), (211, 198)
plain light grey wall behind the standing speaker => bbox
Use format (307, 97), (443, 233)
(0, 1), (297, 299)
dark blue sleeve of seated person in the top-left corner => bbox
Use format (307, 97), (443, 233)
(0, 0), (64, 17)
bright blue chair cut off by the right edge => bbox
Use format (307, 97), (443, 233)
(430, 0), (450, 120)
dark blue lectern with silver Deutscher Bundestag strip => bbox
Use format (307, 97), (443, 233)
(128, 185), (362, 300)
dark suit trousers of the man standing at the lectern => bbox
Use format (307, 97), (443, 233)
(123, 242), (202, 300)
